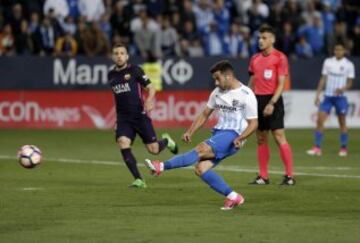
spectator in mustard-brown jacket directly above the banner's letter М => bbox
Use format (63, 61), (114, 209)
(55, 32), (78, 57)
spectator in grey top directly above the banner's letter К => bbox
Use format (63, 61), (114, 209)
(160, 15), (180, 57)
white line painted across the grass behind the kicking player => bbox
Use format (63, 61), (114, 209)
(0, 155), (360, 179)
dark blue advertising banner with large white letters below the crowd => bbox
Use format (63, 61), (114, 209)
(0, 57), (360, 90)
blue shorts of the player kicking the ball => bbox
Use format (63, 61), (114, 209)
(205, 129), (239, 166)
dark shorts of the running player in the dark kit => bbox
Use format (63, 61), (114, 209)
(115, 114), (157, 144)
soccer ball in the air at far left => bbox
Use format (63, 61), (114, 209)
(17, 145), (41, 169)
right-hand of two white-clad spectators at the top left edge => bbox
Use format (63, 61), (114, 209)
(78, 0), (105, 22)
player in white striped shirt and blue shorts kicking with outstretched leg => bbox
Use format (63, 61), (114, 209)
(145, 61), (258, 210)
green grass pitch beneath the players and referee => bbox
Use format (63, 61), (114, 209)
(0, 129), (360, 243)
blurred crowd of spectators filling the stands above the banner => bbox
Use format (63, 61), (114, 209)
(0, 0), (360, 58)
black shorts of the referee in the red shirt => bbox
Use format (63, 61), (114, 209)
(256, 95), (285, 131)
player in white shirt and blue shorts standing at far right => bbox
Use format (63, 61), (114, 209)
(307, 43), (355, 156)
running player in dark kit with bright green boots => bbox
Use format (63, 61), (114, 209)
(108, 44), (178, 188)
